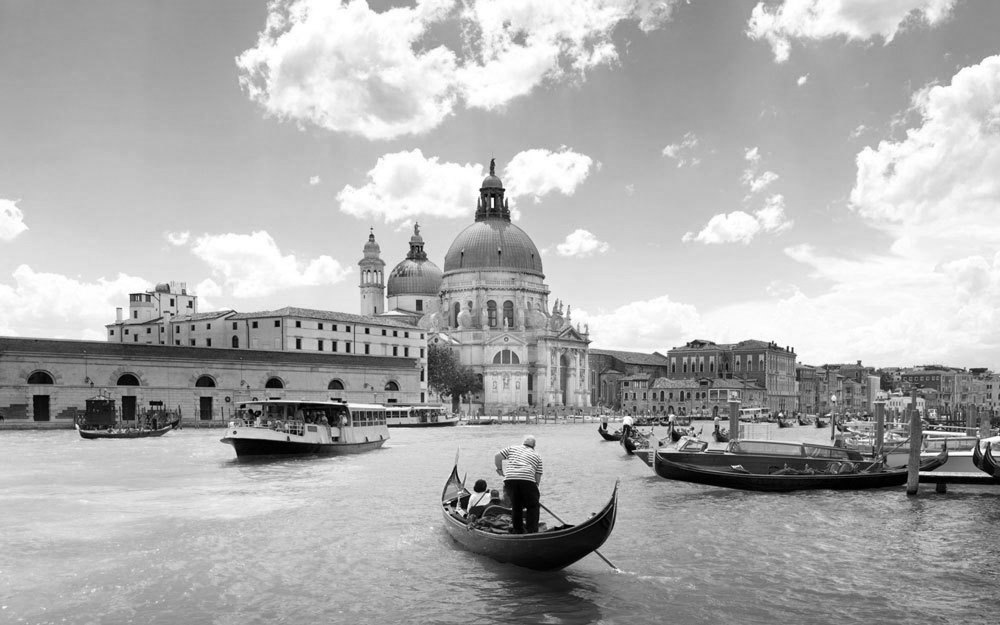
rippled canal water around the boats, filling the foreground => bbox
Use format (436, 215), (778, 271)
(0, 424), (1000, 625)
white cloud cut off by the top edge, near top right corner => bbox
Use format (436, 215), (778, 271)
(747, 0), (955, 63)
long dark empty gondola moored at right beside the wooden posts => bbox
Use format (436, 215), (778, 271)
(653, 449), (948, 492)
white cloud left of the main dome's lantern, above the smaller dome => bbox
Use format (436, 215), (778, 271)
(337, 149), (485, 223)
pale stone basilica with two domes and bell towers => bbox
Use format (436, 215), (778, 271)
(358, 160), (590, 414)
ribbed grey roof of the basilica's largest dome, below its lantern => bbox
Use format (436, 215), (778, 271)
(444, 219), (545, 278)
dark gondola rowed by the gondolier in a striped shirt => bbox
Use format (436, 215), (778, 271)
(441, 464), (618, 571)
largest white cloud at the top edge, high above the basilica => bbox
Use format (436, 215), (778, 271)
(236, 0), (675, 139)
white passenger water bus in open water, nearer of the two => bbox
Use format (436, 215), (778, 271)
(221, 399), (389, 458)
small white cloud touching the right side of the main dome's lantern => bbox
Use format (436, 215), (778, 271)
(503, 146), (594, 202)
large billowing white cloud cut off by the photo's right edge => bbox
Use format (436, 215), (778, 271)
(851, 56), (1000, 260)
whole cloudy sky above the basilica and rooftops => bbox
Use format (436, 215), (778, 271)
(0, 0), (1000, 371)
